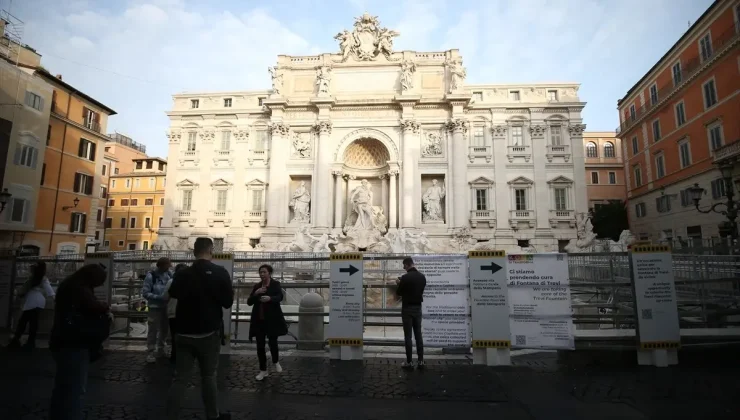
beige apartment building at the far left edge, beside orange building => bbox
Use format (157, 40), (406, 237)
(0, 14), (53, 254)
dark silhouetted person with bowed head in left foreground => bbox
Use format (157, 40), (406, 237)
(49, 264), (113, 420)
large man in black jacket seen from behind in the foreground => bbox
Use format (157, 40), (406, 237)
(167, 238), (234, 420)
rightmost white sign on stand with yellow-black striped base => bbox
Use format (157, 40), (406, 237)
(630, 245), (681, 366)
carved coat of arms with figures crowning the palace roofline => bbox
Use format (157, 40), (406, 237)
(334, 13), (400, 62)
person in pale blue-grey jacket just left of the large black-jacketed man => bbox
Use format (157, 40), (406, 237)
(141, 257), (172, 363)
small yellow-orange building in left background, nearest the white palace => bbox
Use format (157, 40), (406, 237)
(103, 158), (167, 251)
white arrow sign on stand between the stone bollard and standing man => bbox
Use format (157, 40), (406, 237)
(327, 253), (364, 360)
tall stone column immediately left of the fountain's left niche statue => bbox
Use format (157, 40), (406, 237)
(267, 122), (290, 227)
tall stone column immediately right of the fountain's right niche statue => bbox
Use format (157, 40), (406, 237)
(445, 118), (470, 228)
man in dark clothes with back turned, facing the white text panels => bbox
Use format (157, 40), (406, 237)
(396, 257), (427, 369)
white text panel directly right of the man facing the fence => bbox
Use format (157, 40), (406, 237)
(413, 255), (470, 349)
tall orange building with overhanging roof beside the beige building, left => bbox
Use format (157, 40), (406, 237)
(24, 69), (116, 255)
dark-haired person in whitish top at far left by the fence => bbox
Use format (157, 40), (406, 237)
(8, 261), (54, 350)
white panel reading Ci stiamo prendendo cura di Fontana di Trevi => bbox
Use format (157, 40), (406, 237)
(506, 254), (575, 350)
